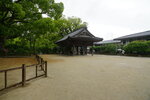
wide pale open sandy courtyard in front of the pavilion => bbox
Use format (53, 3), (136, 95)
(0, 55), (150, 100)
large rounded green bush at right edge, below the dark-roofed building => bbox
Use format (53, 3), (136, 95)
(124, 41), (150, 55)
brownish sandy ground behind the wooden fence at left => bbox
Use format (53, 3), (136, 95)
(0, 56), (37, 89)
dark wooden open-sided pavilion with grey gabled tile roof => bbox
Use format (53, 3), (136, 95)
(56, 27), (103, 55)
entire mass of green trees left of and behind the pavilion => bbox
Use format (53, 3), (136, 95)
(0, 0), (87, 55)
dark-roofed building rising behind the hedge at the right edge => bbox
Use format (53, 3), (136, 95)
(114, 31), (150, 44)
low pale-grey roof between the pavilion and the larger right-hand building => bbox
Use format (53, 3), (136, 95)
(94, 40), (121, 46)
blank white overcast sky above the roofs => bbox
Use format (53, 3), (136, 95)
(55, 0), (150, 40)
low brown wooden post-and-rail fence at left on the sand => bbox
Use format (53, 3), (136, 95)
(0, 55), (47, 91)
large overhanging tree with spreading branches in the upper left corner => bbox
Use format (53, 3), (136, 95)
(0, 0), (64, 54)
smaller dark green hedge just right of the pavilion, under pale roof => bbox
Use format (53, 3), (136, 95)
(93, 44), (117, 54)
